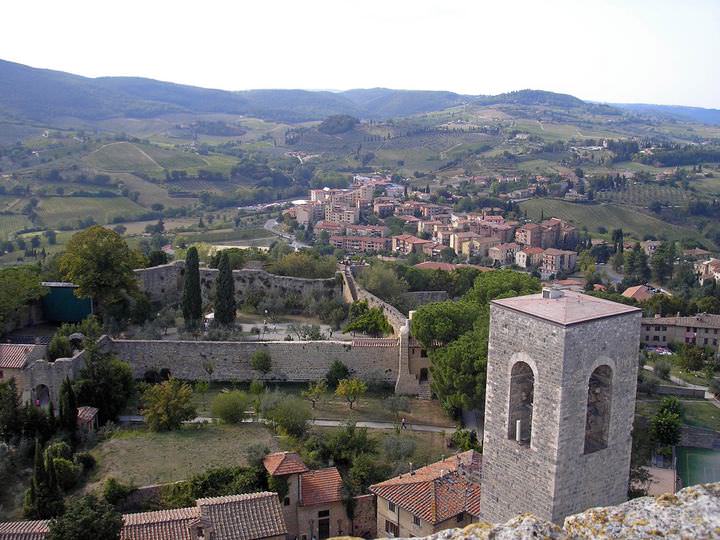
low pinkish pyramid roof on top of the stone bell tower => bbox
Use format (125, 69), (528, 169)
(492, 289), (640, 326)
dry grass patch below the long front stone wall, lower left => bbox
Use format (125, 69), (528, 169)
(88, 424), (277, 489)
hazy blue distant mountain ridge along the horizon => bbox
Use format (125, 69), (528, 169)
(0, 60), (720, 124)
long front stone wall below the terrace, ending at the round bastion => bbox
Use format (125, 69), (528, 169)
(108, 339), (399, 383)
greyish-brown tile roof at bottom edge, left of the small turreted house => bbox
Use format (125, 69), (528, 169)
(197, 491), (287, 540)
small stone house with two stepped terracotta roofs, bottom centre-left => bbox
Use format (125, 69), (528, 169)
(263, 452), (352, 540)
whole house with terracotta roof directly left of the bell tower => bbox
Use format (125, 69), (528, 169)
(370, 450), (482, 538)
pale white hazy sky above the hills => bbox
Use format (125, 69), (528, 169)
(0, 0), (720, 108)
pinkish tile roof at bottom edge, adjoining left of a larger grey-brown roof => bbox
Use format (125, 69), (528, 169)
(120, 507), (200, 540)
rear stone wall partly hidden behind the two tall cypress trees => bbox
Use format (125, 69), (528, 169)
(135, 261), (340, 304)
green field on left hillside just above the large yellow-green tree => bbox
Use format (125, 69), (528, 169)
(37, 197), (147, 227)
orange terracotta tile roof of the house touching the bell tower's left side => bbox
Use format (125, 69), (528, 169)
(370, 450), (482, 524)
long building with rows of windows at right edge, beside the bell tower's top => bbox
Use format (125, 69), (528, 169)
(641, 313), (720, 354)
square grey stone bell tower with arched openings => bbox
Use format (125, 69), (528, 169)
(480, 289), (641, 523)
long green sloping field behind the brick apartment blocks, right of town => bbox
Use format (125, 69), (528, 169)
(520, 199), (708, 244)
